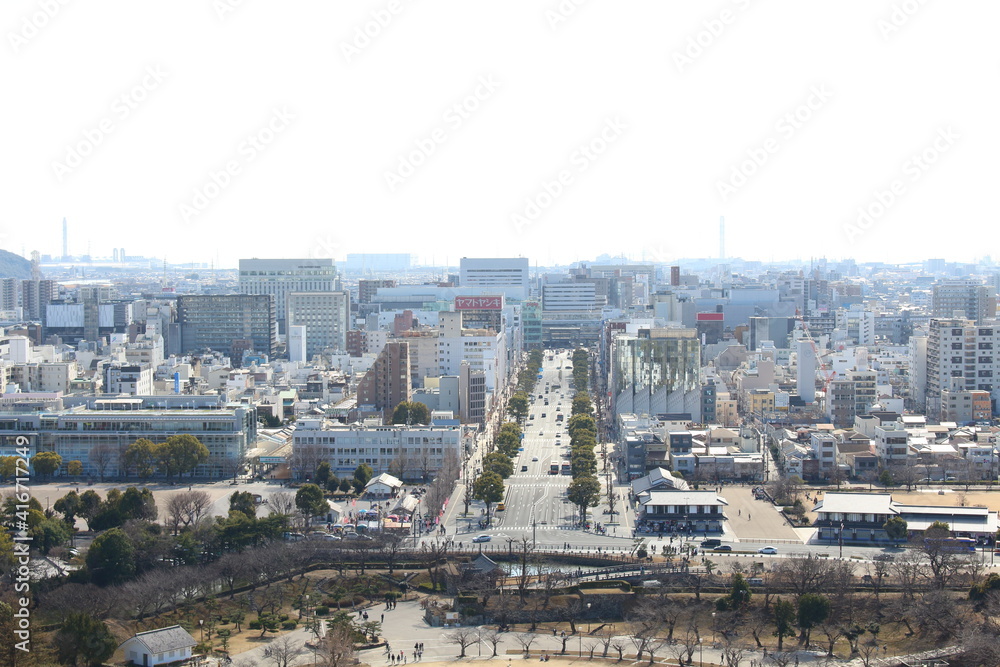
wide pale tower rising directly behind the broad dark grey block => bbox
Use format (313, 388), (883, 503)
(240, 259), (340, 334)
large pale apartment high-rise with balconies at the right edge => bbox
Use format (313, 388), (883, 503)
(926, 318), (1000, 415)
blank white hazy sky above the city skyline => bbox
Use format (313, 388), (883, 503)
(0, 0), (1000, 266)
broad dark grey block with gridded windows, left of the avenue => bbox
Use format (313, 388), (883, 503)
(177, 294), (278, 366)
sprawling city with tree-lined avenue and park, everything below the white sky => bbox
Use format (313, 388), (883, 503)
(0, 250), (1000, 665)
